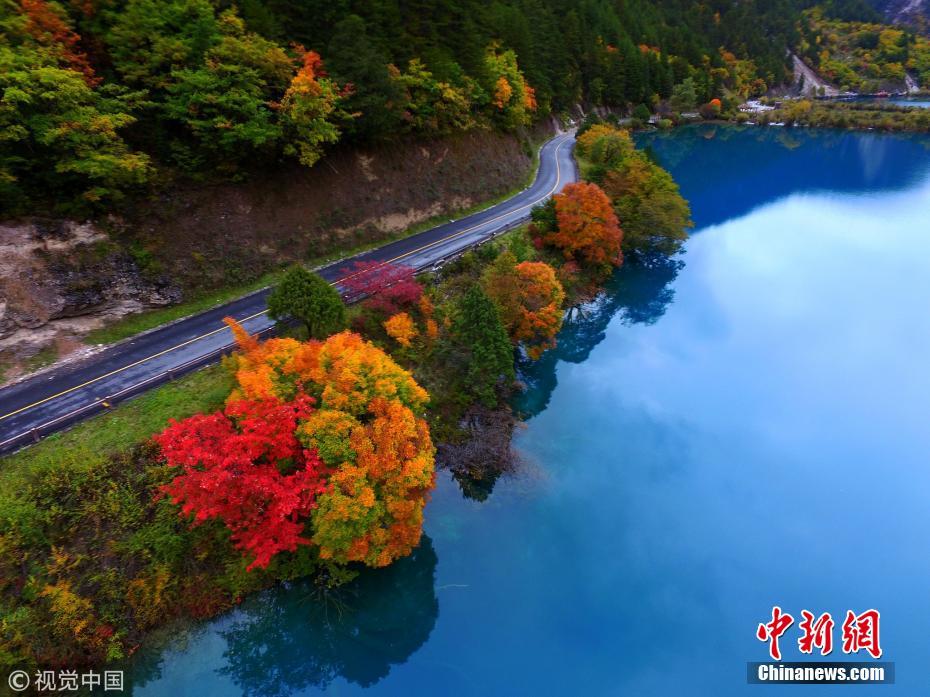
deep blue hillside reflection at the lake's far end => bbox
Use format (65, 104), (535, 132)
(637, 126), (930, 229)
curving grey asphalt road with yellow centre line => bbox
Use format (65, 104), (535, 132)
(0, 133), (577, 453)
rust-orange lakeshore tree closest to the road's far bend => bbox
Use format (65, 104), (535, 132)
(543, 182), (623, 268)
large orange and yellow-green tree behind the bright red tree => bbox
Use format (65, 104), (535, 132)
(222, 320), (435, 566)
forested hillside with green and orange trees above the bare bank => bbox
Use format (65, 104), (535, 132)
(0, 0), (799, 215)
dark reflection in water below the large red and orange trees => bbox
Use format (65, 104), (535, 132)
(220, 536), (439, 697)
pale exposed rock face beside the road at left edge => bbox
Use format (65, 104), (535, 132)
(0, 220), (181, 379)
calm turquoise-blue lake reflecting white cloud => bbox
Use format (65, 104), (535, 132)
(132, 127), (930, 697)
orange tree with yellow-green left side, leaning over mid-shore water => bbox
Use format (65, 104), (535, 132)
(481, 252), (565, 360)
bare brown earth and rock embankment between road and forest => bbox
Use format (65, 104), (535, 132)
(0, 128), (548, 382)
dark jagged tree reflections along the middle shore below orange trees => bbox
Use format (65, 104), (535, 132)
(514, 257), (684, 418)
